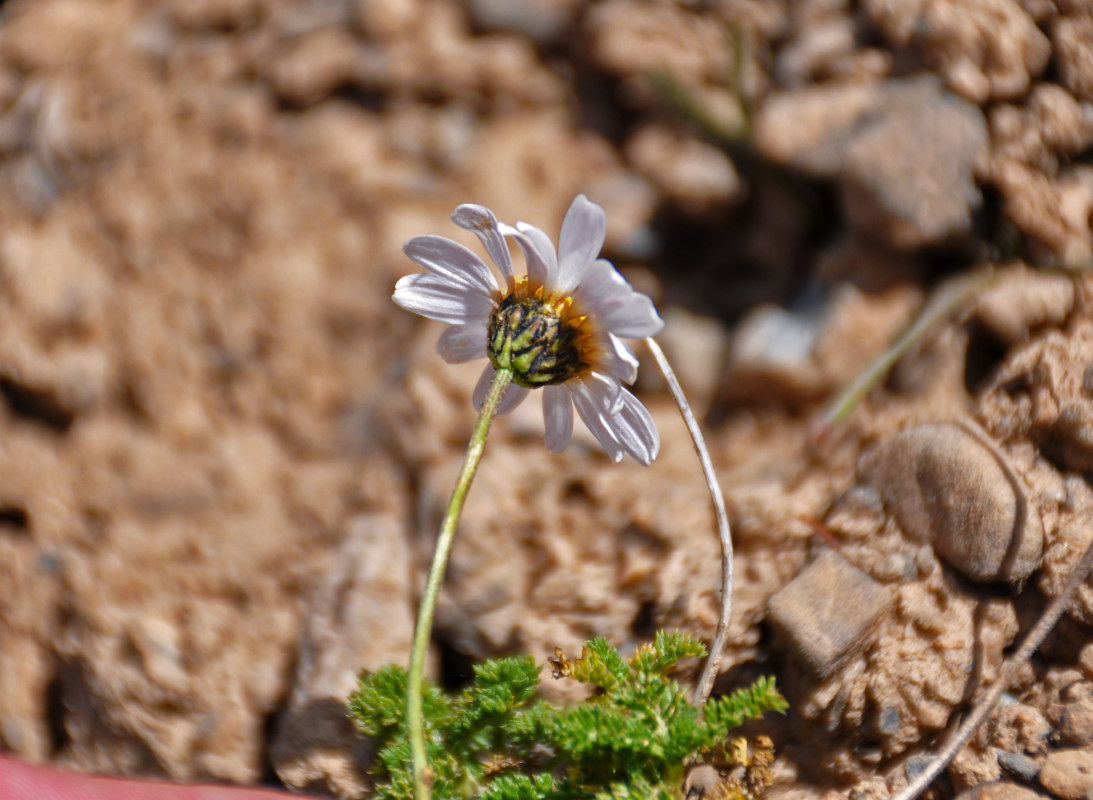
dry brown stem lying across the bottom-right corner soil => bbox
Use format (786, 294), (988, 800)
(892, 528), (1093, 800)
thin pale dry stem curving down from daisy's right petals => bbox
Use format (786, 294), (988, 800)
(645, 337), (733, 706)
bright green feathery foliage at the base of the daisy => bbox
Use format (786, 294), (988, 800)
(349, 632), (787, 800)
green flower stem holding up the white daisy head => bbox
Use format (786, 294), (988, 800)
(407, 369), (513, 800)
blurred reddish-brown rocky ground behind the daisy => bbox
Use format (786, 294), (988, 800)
(0, 0), (1093, 800)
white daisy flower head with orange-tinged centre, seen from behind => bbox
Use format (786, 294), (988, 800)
(392, 195), (665, 464)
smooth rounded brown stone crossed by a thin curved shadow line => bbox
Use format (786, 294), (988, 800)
(859, 423), (1044, 581)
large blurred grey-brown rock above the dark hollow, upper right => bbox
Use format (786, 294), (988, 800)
(755, 75), (987, 249)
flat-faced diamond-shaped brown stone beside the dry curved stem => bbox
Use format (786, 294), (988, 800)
(768, 550), (893, 678)
